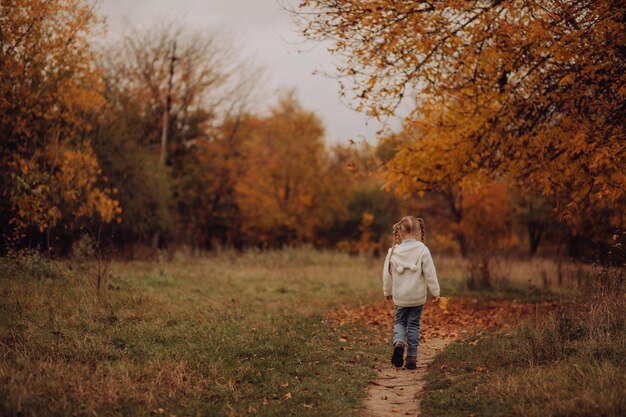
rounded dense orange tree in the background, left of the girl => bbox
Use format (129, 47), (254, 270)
(235, 94), (342, 245)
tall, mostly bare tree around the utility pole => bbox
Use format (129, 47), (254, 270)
(96, 23), (258, 247)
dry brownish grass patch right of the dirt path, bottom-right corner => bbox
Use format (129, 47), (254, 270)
(422, 276), (626, 417)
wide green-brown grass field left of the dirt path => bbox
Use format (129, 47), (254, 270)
(0, 250), (385, 416)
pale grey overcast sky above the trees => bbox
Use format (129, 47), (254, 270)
(97, 0), (400, 143)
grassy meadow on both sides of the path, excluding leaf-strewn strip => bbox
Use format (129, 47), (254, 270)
(0, 249), (626, 417)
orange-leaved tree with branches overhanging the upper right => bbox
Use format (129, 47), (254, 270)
(296, 0), (626, 247)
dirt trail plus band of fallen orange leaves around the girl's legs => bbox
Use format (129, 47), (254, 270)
(324, 298), (557, 417)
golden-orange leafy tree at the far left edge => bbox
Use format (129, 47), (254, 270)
(0, 0), (120, 247)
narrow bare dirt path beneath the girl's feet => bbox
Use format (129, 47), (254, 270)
(363, 338), (451, 417)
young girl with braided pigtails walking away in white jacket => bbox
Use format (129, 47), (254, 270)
(383, 216), (439, 369)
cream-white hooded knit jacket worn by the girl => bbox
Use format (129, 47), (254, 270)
(383, 239), (439, 307)
